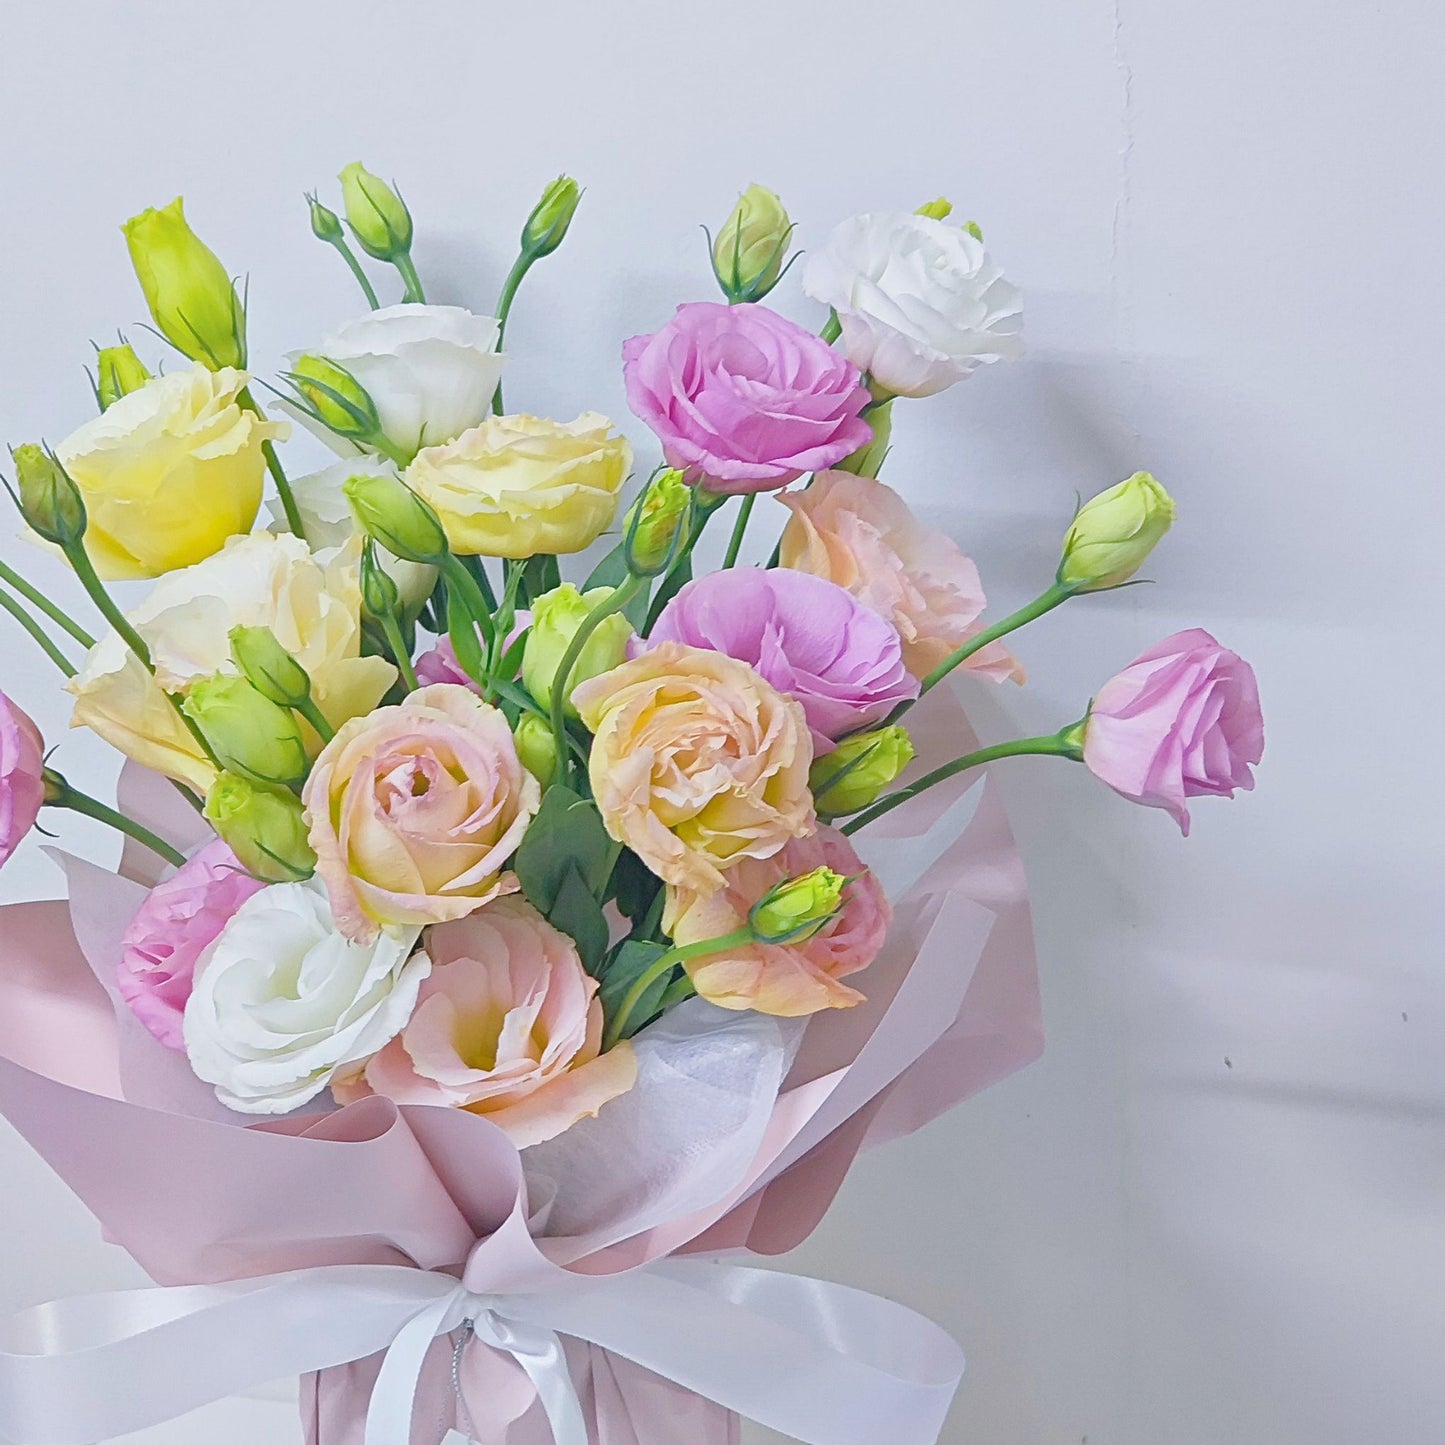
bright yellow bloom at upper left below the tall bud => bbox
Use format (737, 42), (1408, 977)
(55, 363), (290, 578)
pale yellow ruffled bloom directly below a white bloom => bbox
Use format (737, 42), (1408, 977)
(406, 412), (631, 558)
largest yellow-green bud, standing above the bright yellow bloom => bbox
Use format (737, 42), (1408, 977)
(123, 197), (246, 371)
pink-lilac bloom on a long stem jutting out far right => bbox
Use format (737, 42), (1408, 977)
(1084, 627), (1264, 835)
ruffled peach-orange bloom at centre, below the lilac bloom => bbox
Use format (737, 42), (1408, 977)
(572, 643), (816, 894)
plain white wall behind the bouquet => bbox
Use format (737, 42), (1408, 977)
(0, 0), (1445, 1445)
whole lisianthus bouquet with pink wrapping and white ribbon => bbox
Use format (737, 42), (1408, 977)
(0, 165), (1261, 1445)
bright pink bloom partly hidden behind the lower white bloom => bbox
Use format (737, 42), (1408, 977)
(116, 838), (266, 1052)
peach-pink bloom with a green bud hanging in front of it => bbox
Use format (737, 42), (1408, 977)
(663, 827), (893, 1019)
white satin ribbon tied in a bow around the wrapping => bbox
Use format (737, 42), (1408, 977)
(0, 1259), (964, 1445)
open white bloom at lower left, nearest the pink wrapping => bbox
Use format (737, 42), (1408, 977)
(184, 881), (432, 1114)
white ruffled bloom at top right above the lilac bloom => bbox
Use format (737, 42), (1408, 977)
(803, 212), (1023, 396)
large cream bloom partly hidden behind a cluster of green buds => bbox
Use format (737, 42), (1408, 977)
(69, 532), (396, 792)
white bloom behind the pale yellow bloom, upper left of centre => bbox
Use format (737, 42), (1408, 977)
(286, 302), (506, 457)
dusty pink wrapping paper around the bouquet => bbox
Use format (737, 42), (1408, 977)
(0, 689), (1042, 1445)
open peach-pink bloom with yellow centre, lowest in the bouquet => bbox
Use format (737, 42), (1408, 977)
(332, 897), (637, 1149)
